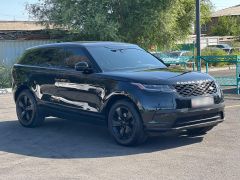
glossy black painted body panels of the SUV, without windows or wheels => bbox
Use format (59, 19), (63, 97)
(12, 42), (224, 131)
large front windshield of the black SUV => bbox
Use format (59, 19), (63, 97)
(87, 46), (166, 71)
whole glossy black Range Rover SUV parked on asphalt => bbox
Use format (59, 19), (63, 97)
(12, 42), (224, 145)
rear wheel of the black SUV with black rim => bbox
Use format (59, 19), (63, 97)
(16, 90), (45, 128)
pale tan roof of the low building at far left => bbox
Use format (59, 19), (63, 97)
(0, 21), (45, 31)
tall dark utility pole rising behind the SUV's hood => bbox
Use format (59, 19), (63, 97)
(196, 0), (201, 72)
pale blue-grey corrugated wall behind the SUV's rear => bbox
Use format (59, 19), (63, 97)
(0, 40), (56, 66)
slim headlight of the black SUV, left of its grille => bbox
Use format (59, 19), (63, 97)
(132, 83), (176, 92)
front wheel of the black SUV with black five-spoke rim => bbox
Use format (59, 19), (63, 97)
(108, 100), (147, 146)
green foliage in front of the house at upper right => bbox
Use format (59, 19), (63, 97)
(211, 16), (240, 36)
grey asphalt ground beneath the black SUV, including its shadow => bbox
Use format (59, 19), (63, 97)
(0, 95), (240, 180)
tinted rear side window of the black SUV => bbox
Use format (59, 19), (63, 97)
(20, 48), (65, 67)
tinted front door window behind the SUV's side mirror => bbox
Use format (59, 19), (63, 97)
(64, 47), (90, 68)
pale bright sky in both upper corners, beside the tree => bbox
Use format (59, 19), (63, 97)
(0, 0), (240, 21)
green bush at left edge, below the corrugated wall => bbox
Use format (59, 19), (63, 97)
(0, 65), (12, 89)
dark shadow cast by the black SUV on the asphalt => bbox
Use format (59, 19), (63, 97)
(0, 118), (203, 159)
